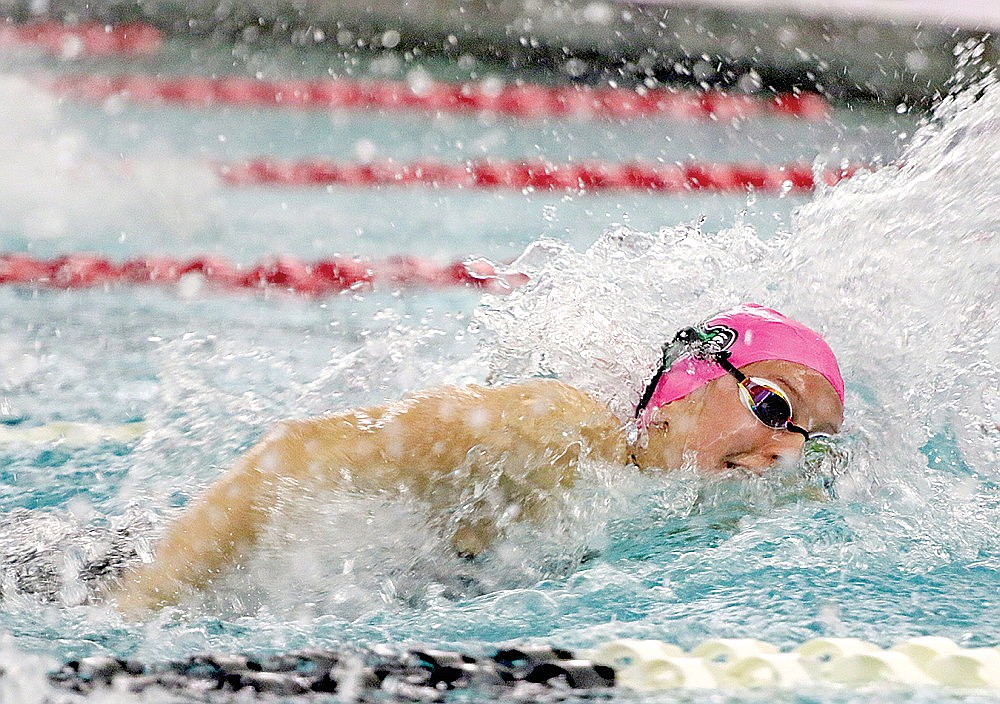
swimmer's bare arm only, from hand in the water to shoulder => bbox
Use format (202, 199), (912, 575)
(112, 407), (449, 612)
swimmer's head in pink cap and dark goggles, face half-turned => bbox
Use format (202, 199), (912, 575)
(636, 304), (844, 470)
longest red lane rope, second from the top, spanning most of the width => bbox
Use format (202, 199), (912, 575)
(48, 75), (830, 120)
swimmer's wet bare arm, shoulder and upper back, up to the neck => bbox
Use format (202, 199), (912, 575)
(116, 382), (621, 610)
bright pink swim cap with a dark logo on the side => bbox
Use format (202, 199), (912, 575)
(646, 303), (844, 410)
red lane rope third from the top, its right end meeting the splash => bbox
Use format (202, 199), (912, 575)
(217, 159), (859, 194)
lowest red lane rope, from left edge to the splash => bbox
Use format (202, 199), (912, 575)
(0, 253), (527, 296)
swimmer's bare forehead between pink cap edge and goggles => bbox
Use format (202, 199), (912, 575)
(742, 360), (844, 432)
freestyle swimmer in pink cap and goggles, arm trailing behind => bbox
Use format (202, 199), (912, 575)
(113, 304), (844, 612)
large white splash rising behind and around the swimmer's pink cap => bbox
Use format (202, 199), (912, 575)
(477, 82), (1000, 484)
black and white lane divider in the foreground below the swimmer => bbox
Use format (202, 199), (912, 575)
(49, 636), (1000, 701)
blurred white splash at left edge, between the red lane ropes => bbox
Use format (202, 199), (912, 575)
(0, 74), (218, 242)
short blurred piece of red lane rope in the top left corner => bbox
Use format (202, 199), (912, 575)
(0, 22), (163, 57)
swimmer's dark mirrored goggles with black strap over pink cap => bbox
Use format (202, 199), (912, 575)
(635, 328), (825, 440)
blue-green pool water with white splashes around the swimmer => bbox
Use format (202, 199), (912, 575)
(0, 27), (1000, 701)
